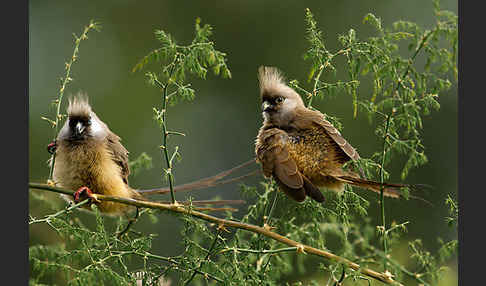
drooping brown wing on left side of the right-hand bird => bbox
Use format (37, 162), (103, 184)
(256, 128), (304, 189)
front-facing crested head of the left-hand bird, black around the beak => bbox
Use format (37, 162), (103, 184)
(58, 94), (108, 142)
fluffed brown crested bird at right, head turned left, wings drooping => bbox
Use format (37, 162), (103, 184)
(255, 66), (409, 202)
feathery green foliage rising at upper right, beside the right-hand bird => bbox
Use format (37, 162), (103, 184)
(294, 2), (457, 179)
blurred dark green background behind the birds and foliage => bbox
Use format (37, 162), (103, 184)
(29, 0), (457, 285)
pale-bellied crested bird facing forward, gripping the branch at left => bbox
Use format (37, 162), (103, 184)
(48, 93), (144, 215)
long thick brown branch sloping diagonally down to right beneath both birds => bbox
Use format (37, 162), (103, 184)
(29, 183), (402, 285)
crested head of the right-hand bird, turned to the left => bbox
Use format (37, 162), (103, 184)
(258, 66), (305, 127)
